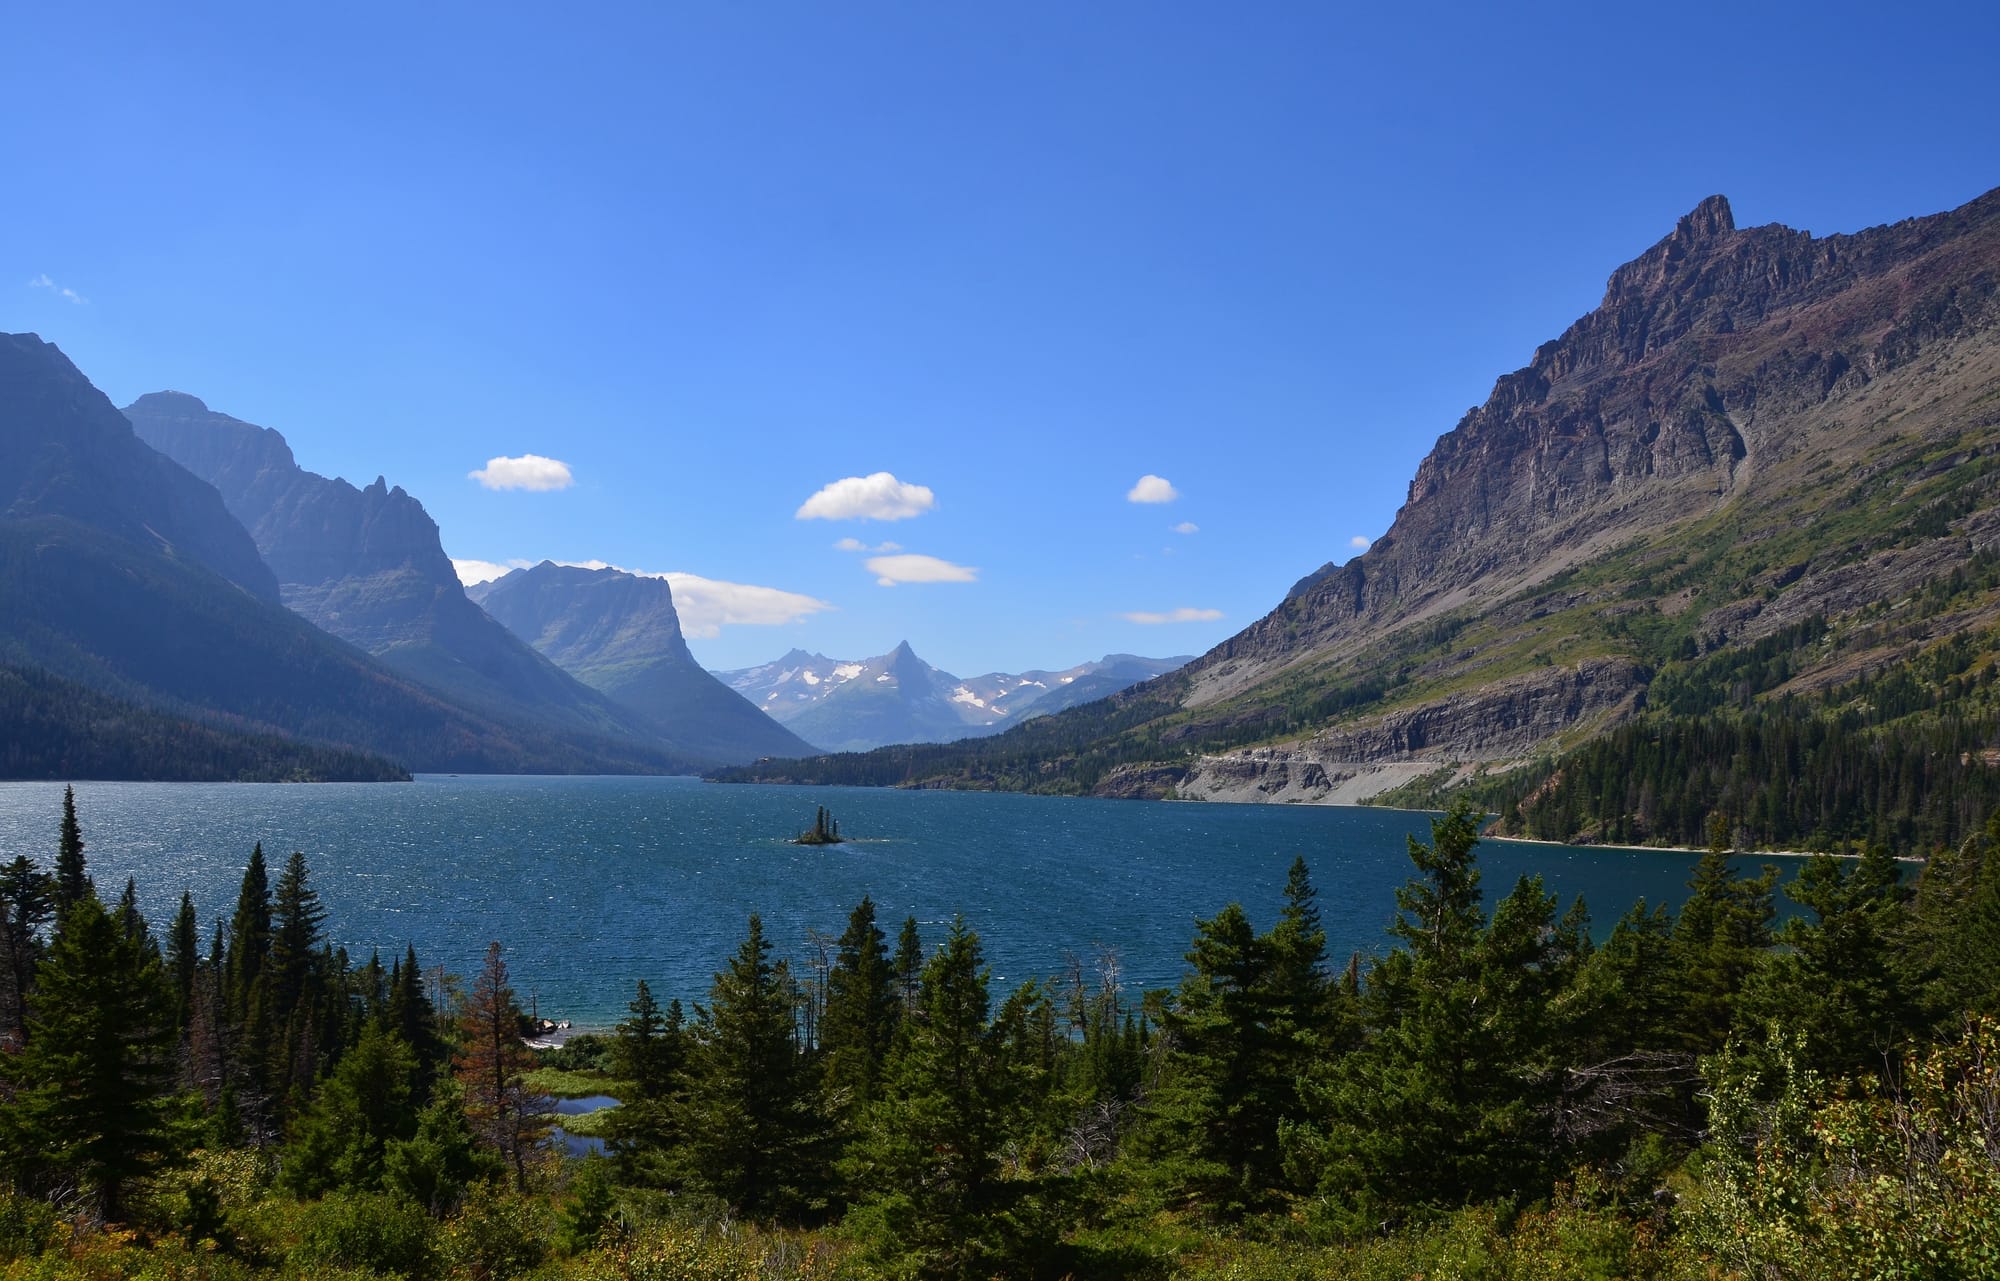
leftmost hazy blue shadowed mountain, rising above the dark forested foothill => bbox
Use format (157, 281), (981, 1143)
(0, 334), (690, 773)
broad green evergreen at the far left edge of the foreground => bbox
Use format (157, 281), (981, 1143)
(0, 893), (178, 1221)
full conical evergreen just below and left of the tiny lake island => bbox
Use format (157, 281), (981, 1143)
(682, 915), (824, 1219)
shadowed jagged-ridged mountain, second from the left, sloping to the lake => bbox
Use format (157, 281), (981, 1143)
(124, 392), (688, 761)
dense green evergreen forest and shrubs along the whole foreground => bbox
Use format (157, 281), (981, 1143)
(0, 784), (2000, 1281)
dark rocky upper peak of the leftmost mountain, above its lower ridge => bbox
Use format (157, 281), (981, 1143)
(0, 334), (278, 600)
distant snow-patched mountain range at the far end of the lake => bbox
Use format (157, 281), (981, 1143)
(718, 641), (1188, 751)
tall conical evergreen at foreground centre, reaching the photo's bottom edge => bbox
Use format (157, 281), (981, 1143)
(842, 917), (1008, 1277)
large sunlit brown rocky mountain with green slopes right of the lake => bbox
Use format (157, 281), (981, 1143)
(716, 192), (2000, 821)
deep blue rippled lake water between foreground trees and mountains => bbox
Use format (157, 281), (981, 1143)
(0, 777), (1800, 1027)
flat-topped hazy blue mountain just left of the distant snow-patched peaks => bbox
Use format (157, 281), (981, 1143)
(470, 560), (810, 761)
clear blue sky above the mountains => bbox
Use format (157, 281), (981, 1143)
(0, 2), (2000, 675)
